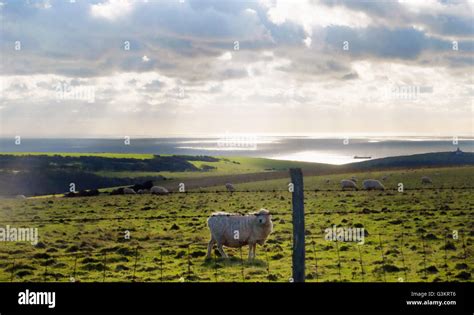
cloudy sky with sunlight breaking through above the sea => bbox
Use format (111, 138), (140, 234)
(0, 0), (474, 137)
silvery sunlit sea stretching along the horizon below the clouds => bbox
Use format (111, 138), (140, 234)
(0, 135), (474, 165)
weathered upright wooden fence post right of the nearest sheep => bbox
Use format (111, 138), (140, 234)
(290, 168), (305, 282)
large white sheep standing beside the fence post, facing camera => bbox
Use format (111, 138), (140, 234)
(206, 209), (273, 259)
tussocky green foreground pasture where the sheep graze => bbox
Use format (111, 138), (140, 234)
(0, 166), (474, 282)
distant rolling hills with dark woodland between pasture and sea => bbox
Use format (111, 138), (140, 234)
(0, 152), (474, 196)
